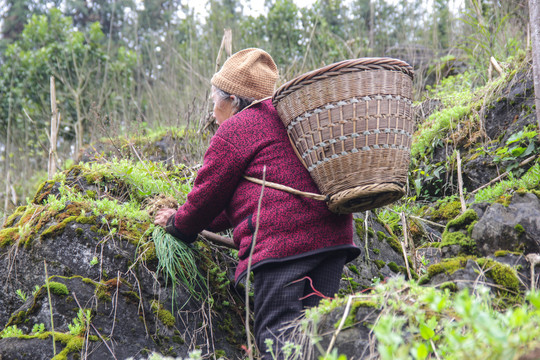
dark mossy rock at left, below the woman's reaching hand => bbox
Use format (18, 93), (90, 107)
(0, 167), (245, 360)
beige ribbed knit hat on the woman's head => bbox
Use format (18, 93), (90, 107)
(211, 48), (278, 100)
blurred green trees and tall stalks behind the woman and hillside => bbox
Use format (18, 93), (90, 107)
(0, 0), (529, 219)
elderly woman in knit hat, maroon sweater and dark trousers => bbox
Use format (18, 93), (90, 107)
(155, 48), (360, 358)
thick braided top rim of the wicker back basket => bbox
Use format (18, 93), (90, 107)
(272, 57), (414, 107)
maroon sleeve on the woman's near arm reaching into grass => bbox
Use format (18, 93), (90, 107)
(174, 134), (247, 236)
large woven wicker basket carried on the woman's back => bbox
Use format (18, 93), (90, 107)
(272, 58), (413, 213)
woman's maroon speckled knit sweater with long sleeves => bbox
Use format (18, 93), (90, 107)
(167, 100), (360, 281)
